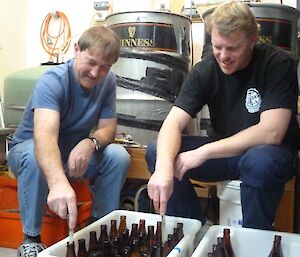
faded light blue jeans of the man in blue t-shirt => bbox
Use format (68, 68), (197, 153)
(8, 140), (130, 236)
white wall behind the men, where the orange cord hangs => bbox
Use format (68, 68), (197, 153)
(0, 0), (296, 96)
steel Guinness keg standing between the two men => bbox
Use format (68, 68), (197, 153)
(105, 11), (192, 143)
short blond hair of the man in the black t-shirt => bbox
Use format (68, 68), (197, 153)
(204, 1), (259, 36)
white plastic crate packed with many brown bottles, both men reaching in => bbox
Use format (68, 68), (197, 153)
(38, 210), (201, 257)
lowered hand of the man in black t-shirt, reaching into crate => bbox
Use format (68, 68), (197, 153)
(148, 171), (174, 214)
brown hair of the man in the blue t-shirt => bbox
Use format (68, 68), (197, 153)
(78, 26), (120, 63)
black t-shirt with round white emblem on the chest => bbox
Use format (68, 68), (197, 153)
(175, 45), (300, 149)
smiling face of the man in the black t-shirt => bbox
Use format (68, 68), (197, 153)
(211, 28), (257, 75)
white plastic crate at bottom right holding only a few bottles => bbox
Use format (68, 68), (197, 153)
(191, 225), (300, 257)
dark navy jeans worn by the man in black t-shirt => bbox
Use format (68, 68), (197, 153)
(146, 136), (299, 230)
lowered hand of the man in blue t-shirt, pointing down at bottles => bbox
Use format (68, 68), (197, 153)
(47, 180), (77, 229)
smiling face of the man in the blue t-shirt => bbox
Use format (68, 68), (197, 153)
(74, 46), (113, 90)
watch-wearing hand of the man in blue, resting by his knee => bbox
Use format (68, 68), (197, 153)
(67, 138), (95, 178)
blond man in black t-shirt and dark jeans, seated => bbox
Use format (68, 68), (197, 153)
(146, 1), (300, 230)
